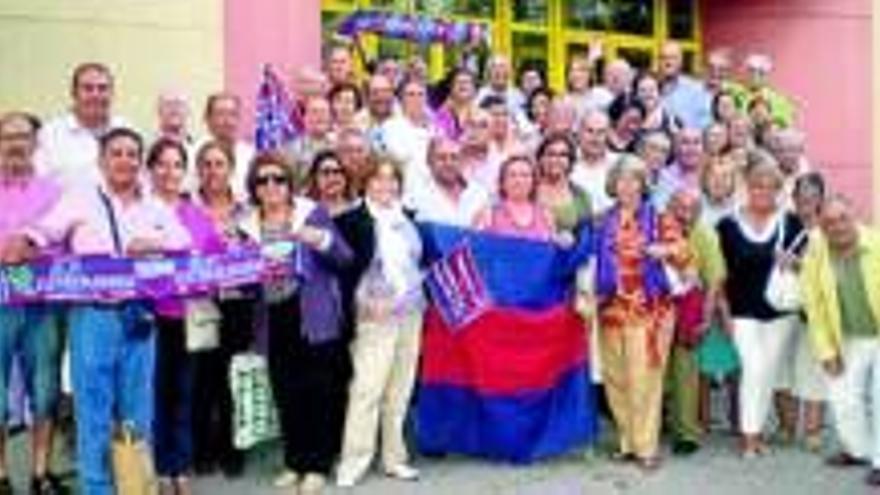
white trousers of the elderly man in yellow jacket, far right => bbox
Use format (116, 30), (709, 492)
(828, 337), (880, 468)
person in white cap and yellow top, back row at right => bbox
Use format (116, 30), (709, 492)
(733, 53), (795, 127)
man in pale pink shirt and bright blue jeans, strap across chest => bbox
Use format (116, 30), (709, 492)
(2, 128), (189, 495)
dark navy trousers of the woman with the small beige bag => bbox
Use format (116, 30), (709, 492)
(153, 317), (193, 477)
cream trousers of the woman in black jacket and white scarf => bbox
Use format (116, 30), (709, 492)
(338, 313), (422, 479)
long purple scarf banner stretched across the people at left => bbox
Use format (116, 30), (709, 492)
(0, 243), (302, 305)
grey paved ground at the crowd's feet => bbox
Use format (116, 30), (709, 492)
(1, 424), (868, 495)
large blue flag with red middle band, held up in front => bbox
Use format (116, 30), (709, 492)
(417, 224), (598, 463)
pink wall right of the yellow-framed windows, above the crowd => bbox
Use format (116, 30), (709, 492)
(703, 0), (872, 216)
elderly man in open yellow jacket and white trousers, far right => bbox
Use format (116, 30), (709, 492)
(801, 196), (880, 486)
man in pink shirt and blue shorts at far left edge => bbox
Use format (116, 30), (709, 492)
(0, 113), (61, 494)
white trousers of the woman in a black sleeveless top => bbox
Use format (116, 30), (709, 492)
(733, 316), (796, 435)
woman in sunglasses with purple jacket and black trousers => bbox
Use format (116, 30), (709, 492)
(241, 154), (352, 493)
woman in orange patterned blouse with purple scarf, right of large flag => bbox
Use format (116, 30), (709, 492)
(596, 155), (690, 469)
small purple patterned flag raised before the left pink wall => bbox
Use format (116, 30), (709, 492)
(254, 65), (302, 152)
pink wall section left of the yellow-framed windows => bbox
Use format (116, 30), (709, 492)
(224, 0), (321, 136)
